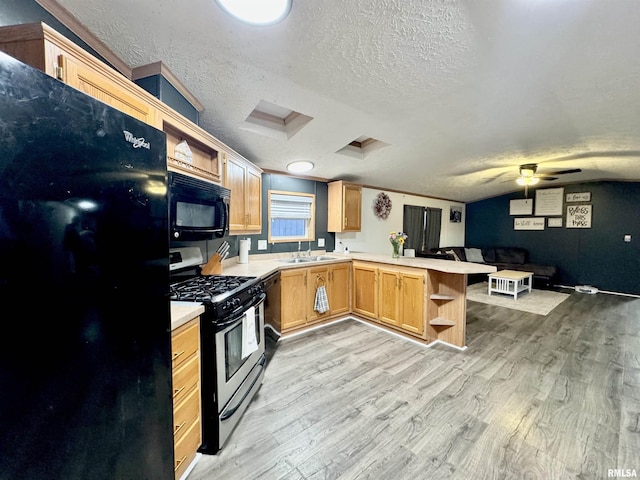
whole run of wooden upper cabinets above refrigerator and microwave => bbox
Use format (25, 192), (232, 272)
(0, 23), (262, 188)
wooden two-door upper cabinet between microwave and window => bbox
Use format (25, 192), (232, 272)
(221, 152), (262, 235)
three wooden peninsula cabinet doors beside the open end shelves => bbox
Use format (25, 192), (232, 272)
(353, 262), (427, 338)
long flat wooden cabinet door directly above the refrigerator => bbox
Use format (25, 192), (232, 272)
(58, 55), (158, 126)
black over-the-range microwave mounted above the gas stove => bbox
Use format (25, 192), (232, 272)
(168, 172), (231, 240)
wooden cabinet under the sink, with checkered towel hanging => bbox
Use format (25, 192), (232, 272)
(268, 262), (351, 333)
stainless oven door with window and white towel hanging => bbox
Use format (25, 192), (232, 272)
(215, 294), (265, 412)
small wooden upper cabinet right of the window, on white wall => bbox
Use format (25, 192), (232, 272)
(327, 180), (362, 232)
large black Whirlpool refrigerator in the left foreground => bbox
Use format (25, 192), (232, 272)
(0, 53), (174, 480)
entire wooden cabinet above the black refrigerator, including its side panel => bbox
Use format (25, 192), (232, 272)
(0, 23), (160, 128)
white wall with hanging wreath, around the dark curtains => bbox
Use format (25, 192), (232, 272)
(336, 188), (466, 255)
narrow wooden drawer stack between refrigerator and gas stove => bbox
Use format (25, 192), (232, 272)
(171, 317), (202, 479)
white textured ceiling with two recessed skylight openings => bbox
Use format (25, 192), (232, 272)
(53, 0), (640, 202)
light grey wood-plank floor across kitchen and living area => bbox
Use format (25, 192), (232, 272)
(188, 292), (640, 480)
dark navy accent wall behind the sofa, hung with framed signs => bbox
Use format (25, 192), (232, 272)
(465, 182), (640, 295)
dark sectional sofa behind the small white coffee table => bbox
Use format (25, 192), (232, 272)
(428, 247), (557, 288)
